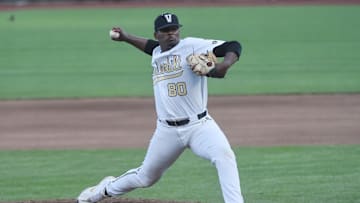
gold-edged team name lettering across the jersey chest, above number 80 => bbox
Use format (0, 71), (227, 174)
(153, 55), (184, 84)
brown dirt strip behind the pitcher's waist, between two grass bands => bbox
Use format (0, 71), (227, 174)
(0, 94), (360, 149)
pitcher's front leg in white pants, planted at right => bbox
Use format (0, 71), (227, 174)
(189, 117), (244, 203)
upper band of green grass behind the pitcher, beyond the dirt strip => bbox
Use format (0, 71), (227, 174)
(0, 6), (360, 99)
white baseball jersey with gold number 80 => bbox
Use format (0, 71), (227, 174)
(151, 37), (225, 120)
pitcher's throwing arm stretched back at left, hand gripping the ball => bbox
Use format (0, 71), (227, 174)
(111, 27), (159, 55)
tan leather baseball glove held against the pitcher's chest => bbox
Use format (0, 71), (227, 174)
(186, 51), (217, 76)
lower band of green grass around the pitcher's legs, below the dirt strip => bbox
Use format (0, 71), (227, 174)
(0, 145), (360, 203)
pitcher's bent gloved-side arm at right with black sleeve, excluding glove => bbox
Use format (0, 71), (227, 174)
(207, 41), (242, 78)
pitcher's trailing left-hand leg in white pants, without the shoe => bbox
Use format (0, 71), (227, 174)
(76, 122), (185, 203)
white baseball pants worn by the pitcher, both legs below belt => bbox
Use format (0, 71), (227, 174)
(106, 115), (244, 203)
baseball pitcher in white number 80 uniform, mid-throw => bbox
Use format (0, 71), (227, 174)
(77, 13), (244, 203)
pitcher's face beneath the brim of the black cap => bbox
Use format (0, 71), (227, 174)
(155, 26), (180, 51)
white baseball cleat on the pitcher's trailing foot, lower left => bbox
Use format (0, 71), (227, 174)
(77, 176), (115, 203)
